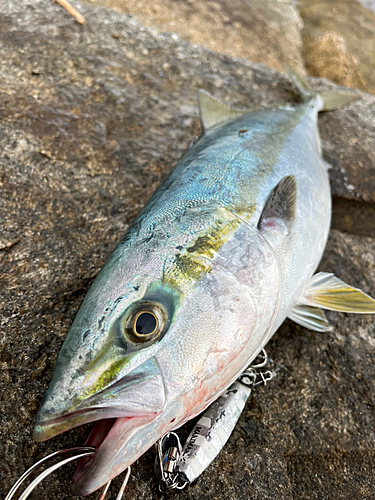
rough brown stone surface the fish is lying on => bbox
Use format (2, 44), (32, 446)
(0, 0), (375, 500)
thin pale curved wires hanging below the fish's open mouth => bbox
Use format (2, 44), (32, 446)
(4, 446), (131, 500)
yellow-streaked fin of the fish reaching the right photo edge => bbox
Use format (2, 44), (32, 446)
(299, 273), (375, 314)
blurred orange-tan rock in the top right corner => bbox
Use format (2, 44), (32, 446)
(297, 0), (375, 94)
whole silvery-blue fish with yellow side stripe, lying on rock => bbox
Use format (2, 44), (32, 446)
(34, 70), (375, 496)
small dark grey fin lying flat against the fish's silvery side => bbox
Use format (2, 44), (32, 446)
(258, 175), (297, 231)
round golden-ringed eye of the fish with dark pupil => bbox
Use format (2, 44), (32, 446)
(123, 301), (168, 344)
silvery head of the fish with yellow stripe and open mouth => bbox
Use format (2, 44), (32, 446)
(34, 208), (280, 495)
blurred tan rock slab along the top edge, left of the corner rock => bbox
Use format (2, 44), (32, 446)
(82, 0), (305, 74)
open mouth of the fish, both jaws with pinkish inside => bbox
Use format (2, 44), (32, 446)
(34, 360), (166, 496)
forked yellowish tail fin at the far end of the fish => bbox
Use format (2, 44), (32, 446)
(285, 64), (361, 111)
